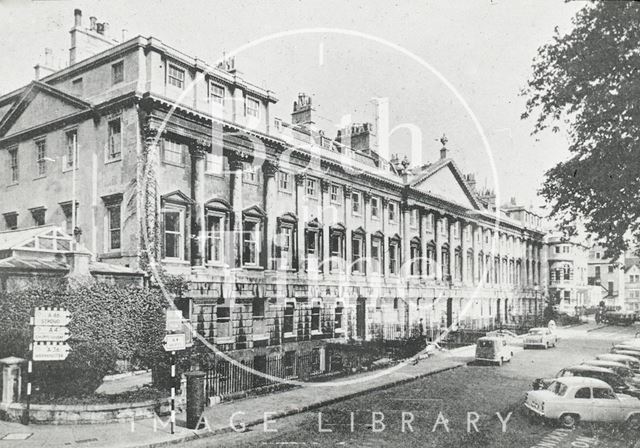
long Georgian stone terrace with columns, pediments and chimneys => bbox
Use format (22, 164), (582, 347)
(0, 10), (543, 369)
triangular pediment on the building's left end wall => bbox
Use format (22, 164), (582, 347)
(0, 81), (91, 137)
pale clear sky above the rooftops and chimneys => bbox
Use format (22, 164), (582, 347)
(0, 0), (584, 212)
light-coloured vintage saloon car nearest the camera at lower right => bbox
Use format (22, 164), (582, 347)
(524, 377), (640, 429)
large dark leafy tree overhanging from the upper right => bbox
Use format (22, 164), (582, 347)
(522, 1), (640, 257)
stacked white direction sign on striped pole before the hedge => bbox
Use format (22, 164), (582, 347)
(24, 307), (71, 425)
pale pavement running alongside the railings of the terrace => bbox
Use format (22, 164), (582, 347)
(0, 345), (475, 448)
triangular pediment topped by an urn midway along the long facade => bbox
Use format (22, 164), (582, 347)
(412, 160), (480, 209)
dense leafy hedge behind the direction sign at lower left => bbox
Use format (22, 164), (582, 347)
(0, 283), (167, 396)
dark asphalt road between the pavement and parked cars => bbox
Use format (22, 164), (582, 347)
(189, 325), (637, 448)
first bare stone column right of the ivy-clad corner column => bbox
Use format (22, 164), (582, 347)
(189, 140), (209, 267)
